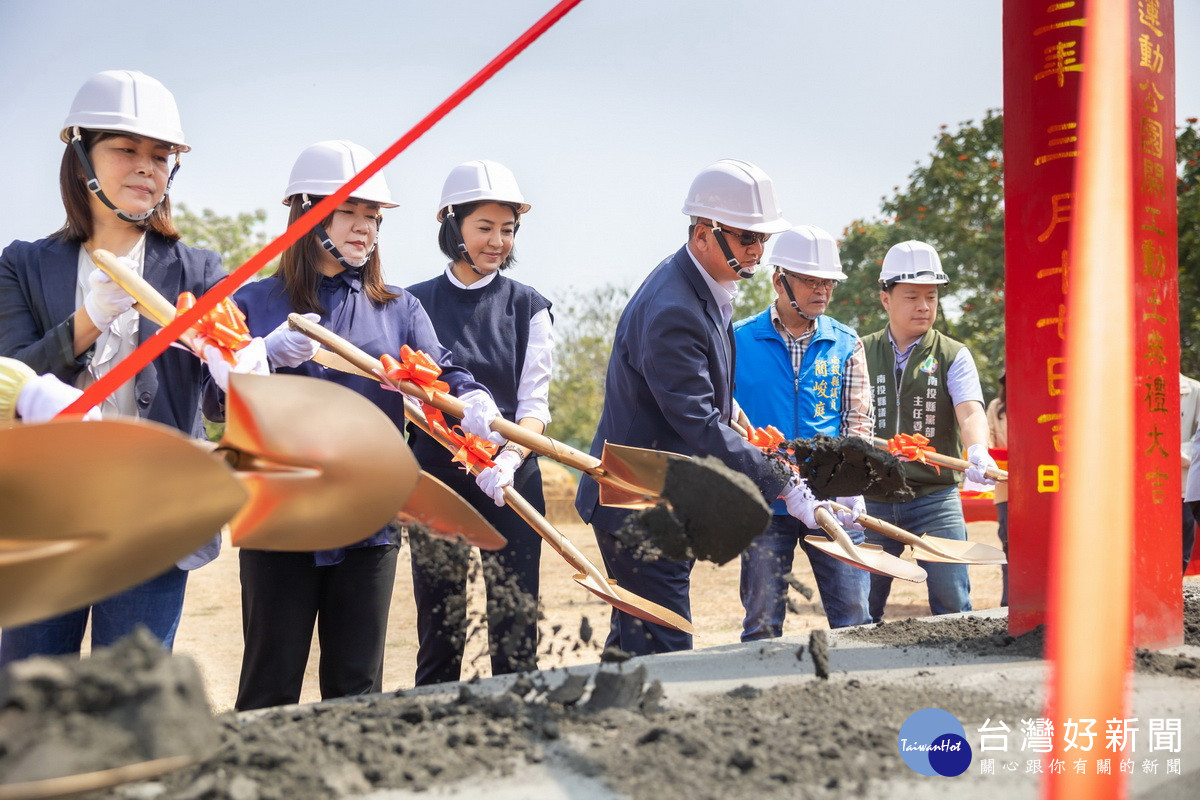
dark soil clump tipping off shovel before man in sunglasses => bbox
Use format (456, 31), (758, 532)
(616, 456), (770, 564)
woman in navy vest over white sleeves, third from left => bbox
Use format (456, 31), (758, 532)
(408, 161), (553, 686)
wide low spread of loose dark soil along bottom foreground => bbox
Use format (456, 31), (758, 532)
(84, 670), (1031, 800)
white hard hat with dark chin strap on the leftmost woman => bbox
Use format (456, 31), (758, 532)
(59, 70), (191, 222)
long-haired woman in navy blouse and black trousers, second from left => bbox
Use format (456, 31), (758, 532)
(205, 140), (503, 711)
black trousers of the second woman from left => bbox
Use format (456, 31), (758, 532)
(235, 545), (398, 711)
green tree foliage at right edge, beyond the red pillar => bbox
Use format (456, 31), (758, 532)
(1175, 116), (1200, 378)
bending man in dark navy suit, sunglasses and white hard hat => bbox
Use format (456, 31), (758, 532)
(575, 160), (830, 655)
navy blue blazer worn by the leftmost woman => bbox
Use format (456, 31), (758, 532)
(0, 231), (224, 437)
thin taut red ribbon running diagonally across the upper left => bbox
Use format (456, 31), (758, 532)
(61, 0), (582, 415)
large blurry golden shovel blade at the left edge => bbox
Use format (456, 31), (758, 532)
(0, 420), (246, 627)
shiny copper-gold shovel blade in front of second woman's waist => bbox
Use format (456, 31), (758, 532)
(218, 374), (420, 552)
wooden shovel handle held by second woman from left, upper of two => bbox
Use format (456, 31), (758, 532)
(288, 314), (607, 477)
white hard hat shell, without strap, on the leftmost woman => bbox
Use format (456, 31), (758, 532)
(59, 70), (191, 152)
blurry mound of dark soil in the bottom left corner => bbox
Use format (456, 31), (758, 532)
(0, 628), (220, 783)
